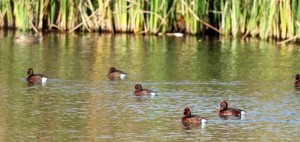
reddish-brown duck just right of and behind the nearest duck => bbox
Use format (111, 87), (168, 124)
(219, 101), (245, 117)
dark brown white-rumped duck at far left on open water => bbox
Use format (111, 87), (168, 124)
(26, 68), (48, 85)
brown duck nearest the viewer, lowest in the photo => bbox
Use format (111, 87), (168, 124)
(181, 107), (206, 124)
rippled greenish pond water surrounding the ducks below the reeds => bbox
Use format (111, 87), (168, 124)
(0, 32), (300, 141)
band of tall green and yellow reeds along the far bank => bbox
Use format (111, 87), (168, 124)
(0, 0), (300, 44)
